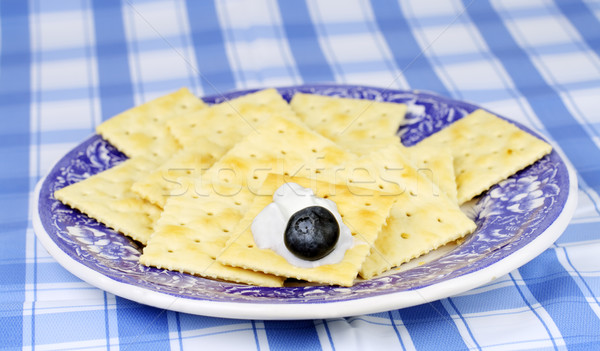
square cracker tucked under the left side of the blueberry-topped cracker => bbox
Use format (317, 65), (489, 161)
(139, 179), (284, 287)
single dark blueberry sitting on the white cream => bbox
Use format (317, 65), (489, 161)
(283, 206), (340, 261)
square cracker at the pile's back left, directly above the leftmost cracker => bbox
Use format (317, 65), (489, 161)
(96, 88), (206, 164)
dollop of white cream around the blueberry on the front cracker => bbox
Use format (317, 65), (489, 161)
(250, 182), (354, 268)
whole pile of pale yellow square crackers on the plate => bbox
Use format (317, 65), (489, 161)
(55, 89), (551, 287)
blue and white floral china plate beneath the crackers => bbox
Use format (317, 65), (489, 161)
(33, 85), (577, 319)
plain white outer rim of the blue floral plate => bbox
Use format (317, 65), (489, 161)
(32, 84), (577, 319)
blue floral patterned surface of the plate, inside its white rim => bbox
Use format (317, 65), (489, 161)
(37, 85), (570, 304)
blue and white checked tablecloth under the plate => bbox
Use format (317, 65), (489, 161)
(0, 0), (600, 350)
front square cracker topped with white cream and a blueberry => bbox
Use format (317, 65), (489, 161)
(217, 174), (394, 286)
